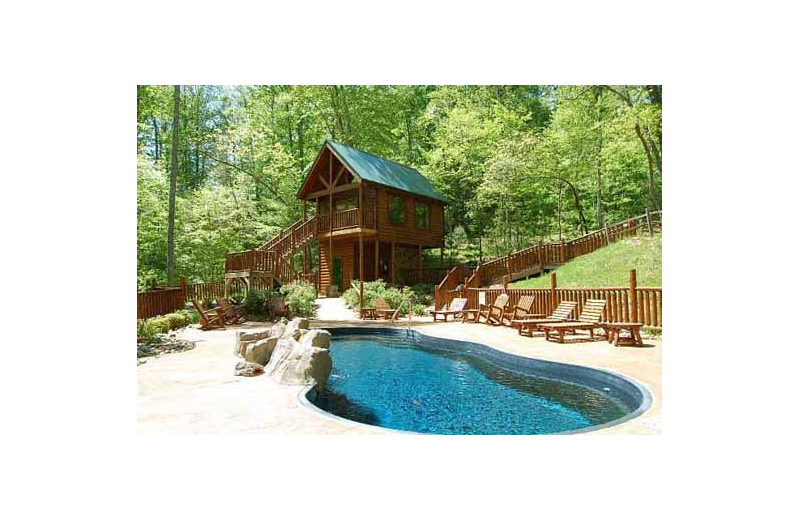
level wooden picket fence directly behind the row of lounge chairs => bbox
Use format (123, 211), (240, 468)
(462, 269), (663, 329)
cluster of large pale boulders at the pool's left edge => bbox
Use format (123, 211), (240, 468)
(235, 318), (333, 390)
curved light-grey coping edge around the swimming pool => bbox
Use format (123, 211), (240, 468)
(298, 326), (653, 435)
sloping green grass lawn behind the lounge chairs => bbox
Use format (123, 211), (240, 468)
(509, 233), (661, 287)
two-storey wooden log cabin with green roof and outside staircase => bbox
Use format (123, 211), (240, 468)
(226, 140), (447, 295)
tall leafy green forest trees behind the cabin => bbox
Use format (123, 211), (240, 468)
(137, 85), (663, 282)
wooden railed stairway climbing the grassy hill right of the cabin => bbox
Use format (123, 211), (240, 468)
(434, 211), (661, 309)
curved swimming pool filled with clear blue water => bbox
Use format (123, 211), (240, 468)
(306, 328), (650, 435)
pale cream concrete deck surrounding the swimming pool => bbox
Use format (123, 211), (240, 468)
(137, 318), (661, 435)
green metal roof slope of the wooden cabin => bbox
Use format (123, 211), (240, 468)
(325, 139), (447, 202)
